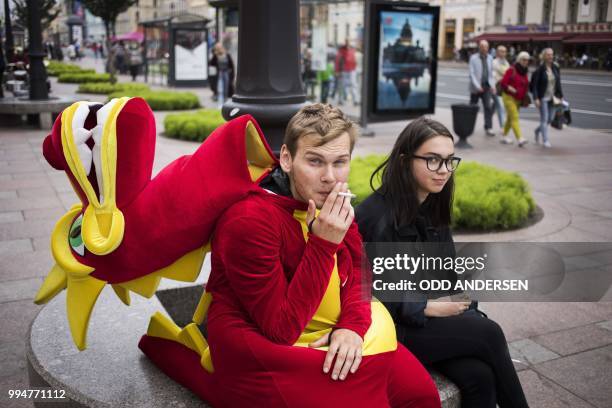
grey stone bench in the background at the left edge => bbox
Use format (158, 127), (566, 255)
(0, 96), (77, 130)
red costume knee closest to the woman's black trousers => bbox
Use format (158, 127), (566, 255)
(388, 344), (440, 408)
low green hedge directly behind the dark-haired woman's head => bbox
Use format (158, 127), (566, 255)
(349, 155), (535, 230)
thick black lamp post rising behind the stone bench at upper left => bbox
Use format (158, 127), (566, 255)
(27, 0), (49, 100)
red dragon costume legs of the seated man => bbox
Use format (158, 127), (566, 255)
(139, 327), (440, 408)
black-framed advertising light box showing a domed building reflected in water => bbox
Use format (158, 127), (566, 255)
(364, 1), (440, 122)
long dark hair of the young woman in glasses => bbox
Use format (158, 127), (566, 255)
(370, 117), (454, 226)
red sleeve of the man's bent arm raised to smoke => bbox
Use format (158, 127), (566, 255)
(213, 214), (338, 345)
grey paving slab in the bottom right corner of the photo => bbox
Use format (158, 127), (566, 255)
(534, 346), (612, 408)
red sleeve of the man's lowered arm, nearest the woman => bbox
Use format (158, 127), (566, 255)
(335, 222), (372, 338)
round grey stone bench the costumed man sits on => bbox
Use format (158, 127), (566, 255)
(26, 281), (460, 408)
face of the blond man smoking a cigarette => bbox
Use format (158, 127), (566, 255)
(280, 132), (351, 209)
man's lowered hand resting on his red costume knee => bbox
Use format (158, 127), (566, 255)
(308, 329), (363, 380)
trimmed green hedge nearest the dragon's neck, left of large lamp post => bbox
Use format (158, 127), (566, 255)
(164, 109), (225, 142)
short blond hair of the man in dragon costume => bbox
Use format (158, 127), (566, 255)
(283, 103), (359, 157)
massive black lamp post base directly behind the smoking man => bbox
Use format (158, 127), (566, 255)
(222, 0), (306, 153)
